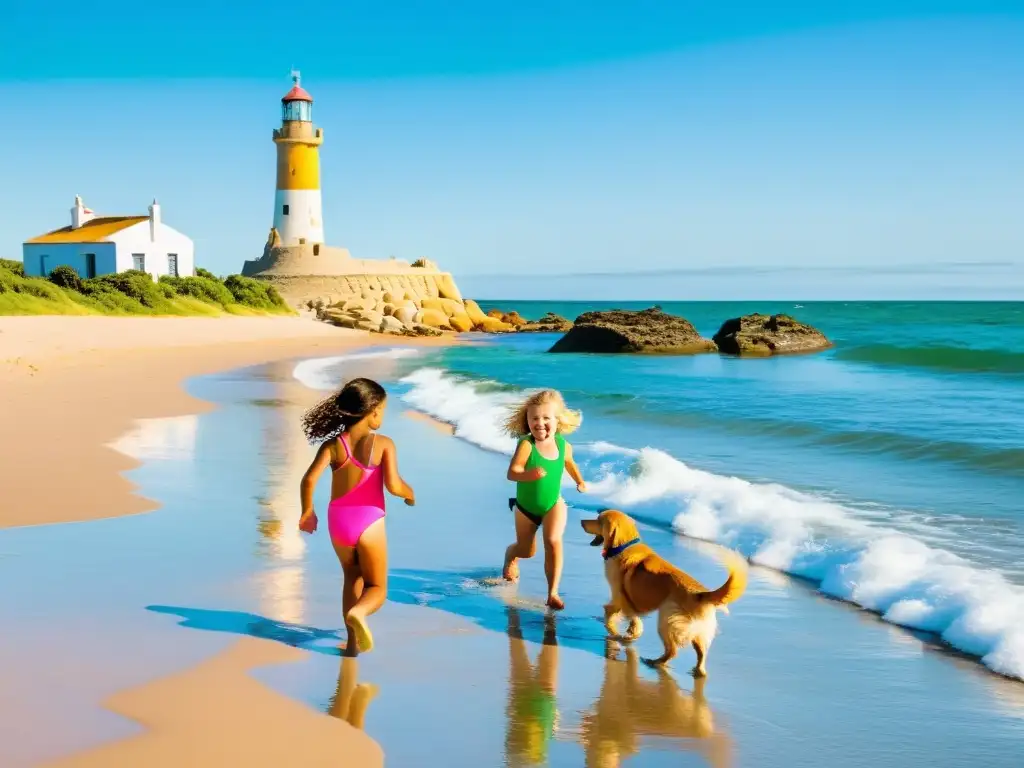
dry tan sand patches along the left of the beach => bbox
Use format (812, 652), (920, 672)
(0, 316), (454, 766)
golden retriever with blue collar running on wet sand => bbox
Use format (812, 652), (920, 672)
(581, 509), (746, 677)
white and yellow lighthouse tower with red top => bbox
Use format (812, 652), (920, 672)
(273, 72), (324, 246)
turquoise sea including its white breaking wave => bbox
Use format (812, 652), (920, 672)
(300, 302), (1024, 677)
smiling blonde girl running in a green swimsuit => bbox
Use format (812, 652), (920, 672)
(502, 389), (587, 610)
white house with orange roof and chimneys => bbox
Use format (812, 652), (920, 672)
(22, 196), (195, 280)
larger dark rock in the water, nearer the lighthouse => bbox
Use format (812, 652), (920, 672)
(548, 307), (716, 354)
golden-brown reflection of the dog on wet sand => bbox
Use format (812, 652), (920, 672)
(581, 639), (732, 768)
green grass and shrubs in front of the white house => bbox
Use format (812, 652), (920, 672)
(0, 259), (295, 316)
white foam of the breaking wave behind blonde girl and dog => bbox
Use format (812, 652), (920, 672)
(402, 368), (1024, 680)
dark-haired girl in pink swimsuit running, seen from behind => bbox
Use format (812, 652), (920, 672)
(299, 379), (416, 655)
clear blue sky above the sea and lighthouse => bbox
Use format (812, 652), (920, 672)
(0, 0), (1024, 299)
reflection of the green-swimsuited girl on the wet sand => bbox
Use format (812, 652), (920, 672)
(505, 605), (558, 766)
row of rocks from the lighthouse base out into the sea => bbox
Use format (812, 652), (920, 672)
(317, 296), (833, 357)
